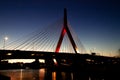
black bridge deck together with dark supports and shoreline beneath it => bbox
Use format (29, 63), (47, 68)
(0, 50), (120, 68)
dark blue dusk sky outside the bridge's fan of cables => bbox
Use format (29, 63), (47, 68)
(0, 0), (120, 55)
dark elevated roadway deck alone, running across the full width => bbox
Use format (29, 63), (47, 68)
(0, 50), (120, 64)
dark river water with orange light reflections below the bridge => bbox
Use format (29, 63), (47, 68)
(0, 68), (120, 80)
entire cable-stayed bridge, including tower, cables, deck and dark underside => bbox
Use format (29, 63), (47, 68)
(0, 9), (120, 69)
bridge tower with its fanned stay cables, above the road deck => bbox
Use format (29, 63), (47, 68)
(3, 10), (85, 53)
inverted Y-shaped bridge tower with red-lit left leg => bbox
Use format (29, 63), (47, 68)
(55, 8), (77, 53)
